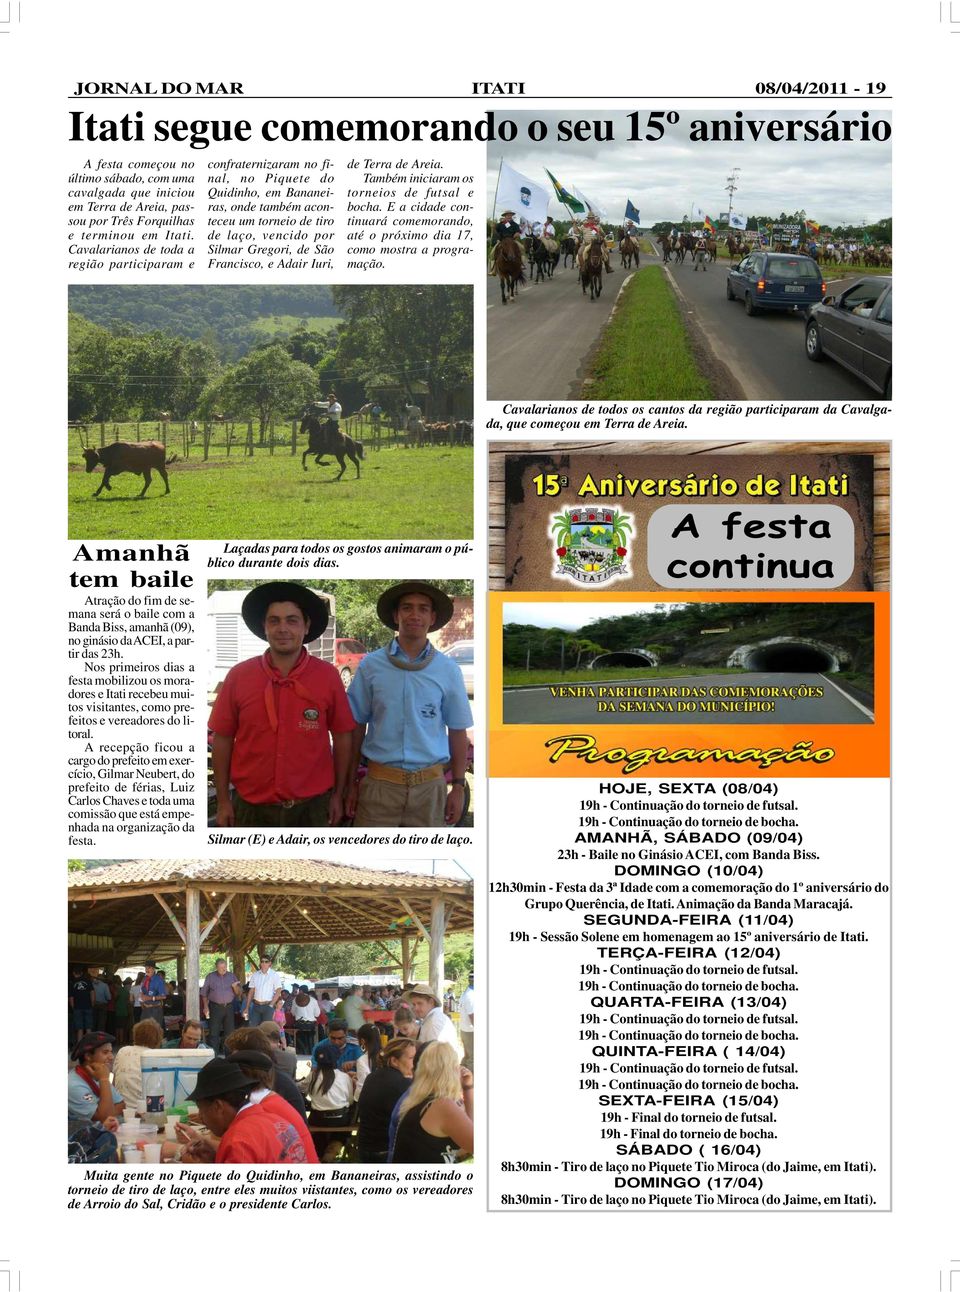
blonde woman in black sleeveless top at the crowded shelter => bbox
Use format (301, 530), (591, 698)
(390, 1041), (473, 1163)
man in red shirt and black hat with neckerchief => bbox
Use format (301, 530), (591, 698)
(209, 583), (354, 828)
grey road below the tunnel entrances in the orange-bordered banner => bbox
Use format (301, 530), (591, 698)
(504, 671), (873, 731)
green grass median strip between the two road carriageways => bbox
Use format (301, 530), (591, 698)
(581, 265), (713, 399)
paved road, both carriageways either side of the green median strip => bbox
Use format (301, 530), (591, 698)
(487, 242), (875, 403)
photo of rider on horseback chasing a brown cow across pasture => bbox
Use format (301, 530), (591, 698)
(67, 284), (473, 540)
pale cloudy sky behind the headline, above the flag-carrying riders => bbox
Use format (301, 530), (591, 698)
(487, 107), (893, 227)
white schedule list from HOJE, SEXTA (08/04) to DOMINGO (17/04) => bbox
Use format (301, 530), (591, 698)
(488, 778), (890, 1212)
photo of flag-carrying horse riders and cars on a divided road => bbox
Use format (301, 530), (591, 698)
(487, 113), (893, 403)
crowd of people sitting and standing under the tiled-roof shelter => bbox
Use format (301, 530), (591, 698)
(68, 971), (474, 1164)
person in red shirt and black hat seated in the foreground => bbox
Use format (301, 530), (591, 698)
(180, 1059), (317, 1164)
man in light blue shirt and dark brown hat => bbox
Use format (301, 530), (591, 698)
(348, 581), (473, 826)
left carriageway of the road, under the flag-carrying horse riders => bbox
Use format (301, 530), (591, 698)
(487, 255), (638, 399)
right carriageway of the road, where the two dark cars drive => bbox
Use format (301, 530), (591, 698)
(667, 258), (876, 403)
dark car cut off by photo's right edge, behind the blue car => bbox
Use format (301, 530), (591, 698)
(805, 274), (893, 399)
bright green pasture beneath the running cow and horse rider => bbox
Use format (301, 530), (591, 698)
(67, 433), (473, 540)
